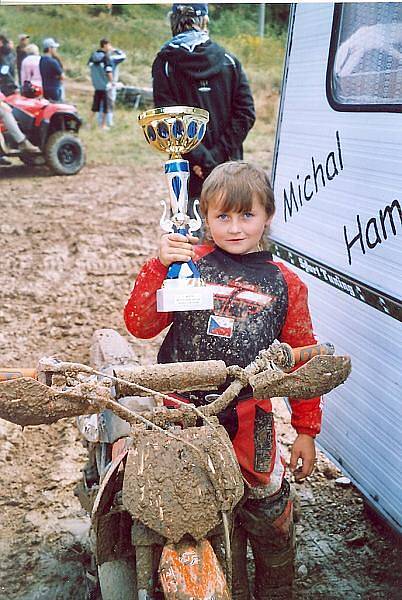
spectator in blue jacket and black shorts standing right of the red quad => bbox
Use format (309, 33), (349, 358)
(88, 38), (113, 130)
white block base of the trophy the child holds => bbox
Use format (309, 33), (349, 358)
(156, 279), (214, 312)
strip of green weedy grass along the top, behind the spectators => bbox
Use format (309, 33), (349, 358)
(0, 4), (284, 88)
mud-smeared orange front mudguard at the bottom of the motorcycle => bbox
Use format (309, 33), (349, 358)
(159, 540), (231, 600)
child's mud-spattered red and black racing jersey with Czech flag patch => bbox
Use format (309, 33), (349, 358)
(124, 245), (321, 426)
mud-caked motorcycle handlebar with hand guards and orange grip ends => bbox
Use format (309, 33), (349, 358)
(0, 343), (350, 426)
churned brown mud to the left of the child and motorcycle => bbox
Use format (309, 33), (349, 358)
(0, 167), (164, 600)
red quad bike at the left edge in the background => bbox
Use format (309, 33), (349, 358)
(0, 86), (85, 175)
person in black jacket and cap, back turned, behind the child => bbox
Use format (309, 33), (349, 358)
(152, 4), (255, 205)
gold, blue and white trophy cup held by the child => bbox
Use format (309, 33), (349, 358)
(138, 106), (213, 312)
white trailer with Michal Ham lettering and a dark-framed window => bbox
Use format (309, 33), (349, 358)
(272, 2), (402, 532)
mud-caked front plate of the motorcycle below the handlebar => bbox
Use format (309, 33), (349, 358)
(123, 425), (244, 542)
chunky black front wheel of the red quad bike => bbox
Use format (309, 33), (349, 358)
(45, 131), (85, 175)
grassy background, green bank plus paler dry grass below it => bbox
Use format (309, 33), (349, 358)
(0, 4), (285, 168)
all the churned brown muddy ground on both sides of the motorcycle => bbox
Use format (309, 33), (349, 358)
(0, 161), (402, 600)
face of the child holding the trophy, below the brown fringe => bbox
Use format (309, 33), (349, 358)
(206, 196), (272, 254)
